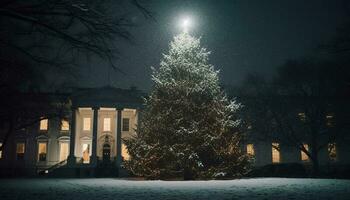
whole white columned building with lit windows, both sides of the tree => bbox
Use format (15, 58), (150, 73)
(0, 87), (350, 177)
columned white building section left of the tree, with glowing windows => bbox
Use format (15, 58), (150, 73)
(0, 87), (142, 177)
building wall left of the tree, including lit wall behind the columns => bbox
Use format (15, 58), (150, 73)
(0, 108), (138, 174)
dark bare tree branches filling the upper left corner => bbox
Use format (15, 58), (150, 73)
(0, 0), (152, 150)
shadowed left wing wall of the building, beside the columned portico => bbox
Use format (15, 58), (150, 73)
(0, 118), (70, 175)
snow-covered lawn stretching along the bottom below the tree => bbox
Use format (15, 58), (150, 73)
(0, 178), (350, 200)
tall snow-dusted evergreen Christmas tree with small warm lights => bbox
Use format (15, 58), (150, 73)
(124, 33), (249, 179)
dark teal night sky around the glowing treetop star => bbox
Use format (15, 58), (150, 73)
(75, 0), (347, 91)
